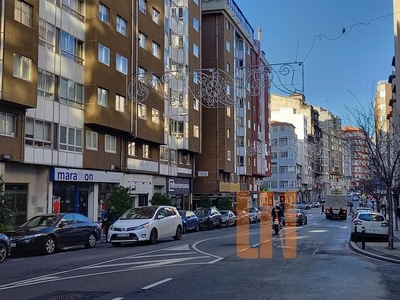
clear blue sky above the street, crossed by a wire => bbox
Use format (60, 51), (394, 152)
(235, 0), (394, 122)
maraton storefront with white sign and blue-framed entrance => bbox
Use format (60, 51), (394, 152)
(49, 168), (123, 220)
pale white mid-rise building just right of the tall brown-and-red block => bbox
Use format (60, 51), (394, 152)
(264, 120), (302, 201)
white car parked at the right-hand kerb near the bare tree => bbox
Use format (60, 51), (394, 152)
(351, 211), (389, 241)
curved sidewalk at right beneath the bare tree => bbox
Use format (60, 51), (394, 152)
(349, 219), (400, 264)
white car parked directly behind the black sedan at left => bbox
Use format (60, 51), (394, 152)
(107, 206), (182, 246)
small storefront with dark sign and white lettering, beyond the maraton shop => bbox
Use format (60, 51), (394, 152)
(167, 177), (192, 210)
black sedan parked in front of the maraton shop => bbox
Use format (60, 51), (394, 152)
(5, 213), (101, 254)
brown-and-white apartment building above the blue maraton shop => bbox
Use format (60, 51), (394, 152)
(0, 0), (201, 225)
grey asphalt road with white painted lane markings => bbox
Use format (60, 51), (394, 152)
(0, 209), (400, 300)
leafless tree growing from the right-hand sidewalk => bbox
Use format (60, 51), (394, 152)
(345, 92), (400, 249)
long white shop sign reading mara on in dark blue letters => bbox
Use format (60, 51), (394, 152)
(50, 168), (123, 183)
